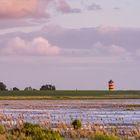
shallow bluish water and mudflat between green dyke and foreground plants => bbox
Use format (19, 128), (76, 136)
(0, 99), (140, 128)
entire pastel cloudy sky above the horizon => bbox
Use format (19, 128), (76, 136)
(0, 0), (140, 90)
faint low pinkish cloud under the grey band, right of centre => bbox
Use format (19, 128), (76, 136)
(62, 42), (130, 58)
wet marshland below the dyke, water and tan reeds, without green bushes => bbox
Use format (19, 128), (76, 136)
(0, 99), (140, 140)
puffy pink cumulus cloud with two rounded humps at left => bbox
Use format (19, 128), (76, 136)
(0, 37), (60, 56)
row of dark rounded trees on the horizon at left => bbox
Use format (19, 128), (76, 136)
(0, 82), (56, 91)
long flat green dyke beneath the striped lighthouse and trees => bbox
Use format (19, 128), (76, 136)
(0, 90), (140, 99)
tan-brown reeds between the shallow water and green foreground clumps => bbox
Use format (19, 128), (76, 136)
(0, 114), (140, 140)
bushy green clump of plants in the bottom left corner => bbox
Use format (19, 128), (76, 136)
(0, 123), (63, 140)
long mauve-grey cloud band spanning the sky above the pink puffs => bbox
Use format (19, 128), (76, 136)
(0, 25), (140, 52)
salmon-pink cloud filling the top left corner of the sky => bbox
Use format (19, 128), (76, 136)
(0, 0), (50, 19)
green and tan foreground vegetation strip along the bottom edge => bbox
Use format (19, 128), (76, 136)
(0, 122), (139, 140)
